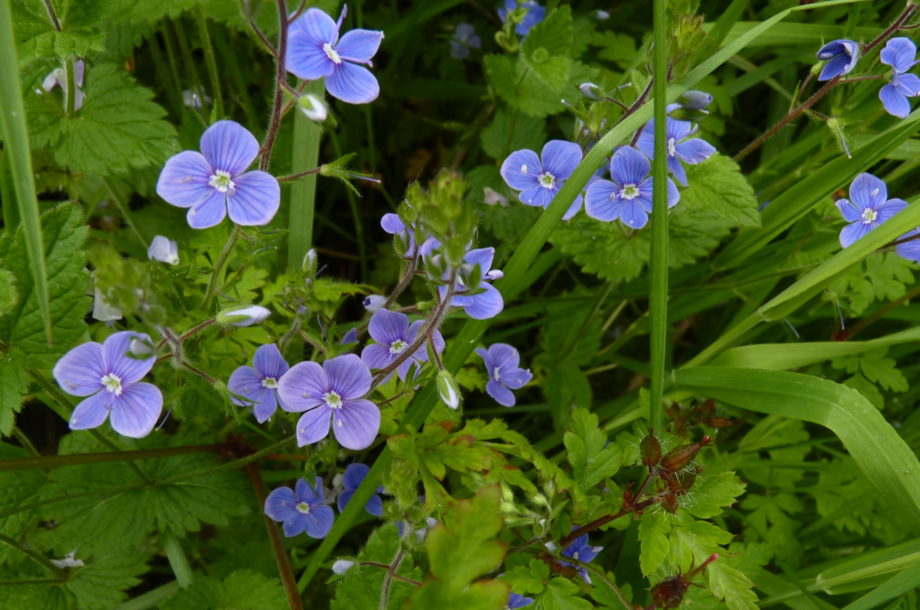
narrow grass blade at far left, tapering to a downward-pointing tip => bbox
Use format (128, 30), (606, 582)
(0, 0), (52, 345)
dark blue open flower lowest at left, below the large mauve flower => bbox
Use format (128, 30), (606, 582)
(264, 477), (335, 538)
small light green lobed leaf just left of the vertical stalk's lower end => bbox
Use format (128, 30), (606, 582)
(563, 409), (623, 491)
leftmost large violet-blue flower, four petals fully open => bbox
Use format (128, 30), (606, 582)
(54, 331), (163, 438)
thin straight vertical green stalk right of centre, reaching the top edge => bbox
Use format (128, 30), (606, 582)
(649, 0), (668, 430)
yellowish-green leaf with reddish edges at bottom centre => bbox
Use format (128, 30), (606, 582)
(412, 485), (508, 609)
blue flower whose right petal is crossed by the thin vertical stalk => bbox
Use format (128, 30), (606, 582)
(585, 146), (680, 229)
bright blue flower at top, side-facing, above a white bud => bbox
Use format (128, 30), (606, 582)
(285, 7), (383, 104)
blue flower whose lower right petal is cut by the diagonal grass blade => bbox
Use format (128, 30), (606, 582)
(500, 140), (582, 220)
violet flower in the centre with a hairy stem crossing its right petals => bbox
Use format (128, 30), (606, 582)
(361, 309), (444, 380)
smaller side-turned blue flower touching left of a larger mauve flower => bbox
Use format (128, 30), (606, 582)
(227, 343), (288, 424)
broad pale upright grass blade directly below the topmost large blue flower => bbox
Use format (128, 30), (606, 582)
(288, 81), (323, 272)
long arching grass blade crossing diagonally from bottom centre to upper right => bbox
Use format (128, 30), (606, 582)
(297, 0), (860, 591)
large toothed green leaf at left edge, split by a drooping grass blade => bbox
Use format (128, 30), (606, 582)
(0, 204), (89, 368)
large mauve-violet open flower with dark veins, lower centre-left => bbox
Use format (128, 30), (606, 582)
(278, 354), (380, 449)
